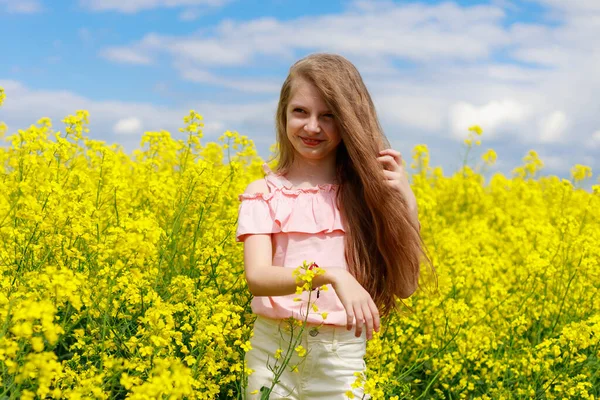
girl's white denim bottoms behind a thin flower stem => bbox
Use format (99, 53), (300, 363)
(245, 315), (371, 400)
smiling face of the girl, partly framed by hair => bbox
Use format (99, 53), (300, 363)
(286, 78), (342, 160)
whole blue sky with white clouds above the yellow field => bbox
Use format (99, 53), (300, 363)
(0, 0), (600, 188)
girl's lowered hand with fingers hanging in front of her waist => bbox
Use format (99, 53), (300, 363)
(327, 268), (379, 340)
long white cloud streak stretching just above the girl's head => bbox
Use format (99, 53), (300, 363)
(101, 3), (510, 66)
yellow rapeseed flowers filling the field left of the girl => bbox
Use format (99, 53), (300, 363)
(0, 89), (260, 399)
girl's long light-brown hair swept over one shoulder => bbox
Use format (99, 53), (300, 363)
(275, 53), (433, 316)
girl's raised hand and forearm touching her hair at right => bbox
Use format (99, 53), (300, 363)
(377, 149), (421, 231)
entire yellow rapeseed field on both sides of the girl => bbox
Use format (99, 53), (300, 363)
(0, 86), (600, 399)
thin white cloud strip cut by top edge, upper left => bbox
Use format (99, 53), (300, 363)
(79, 0), (230, 14)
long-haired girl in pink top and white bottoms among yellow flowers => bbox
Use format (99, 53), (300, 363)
(236, 54), (424, 399)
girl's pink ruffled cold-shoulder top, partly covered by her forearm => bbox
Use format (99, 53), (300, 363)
(236, 163), (348, 326)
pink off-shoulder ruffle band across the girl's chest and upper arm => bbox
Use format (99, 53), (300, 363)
(236, 185), (345, 242)
